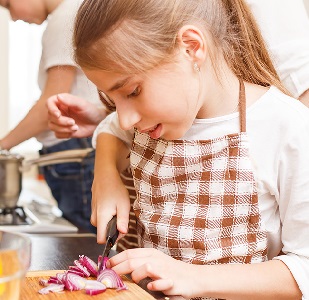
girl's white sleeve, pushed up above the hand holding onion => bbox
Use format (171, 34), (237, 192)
(275, 101), (309, 300)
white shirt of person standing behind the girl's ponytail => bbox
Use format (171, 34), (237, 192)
(247, 0), (309, 98)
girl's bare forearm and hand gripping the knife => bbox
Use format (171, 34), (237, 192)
(91, 133), (130, 243)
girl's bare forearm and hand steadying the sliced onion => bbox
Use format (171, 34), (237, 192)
(109, 249), (302, 300)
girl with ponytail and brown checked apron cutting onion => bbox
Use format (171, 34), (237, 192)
(74, 0), (309, 299)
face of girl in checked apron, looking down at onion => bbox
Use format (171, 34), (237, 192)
(84, 60), (202, 140)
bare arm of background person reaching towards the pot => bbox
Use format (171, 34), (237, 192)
(0, 66), (76, 150)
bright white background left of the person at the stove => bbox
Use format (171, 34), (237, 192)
(0, 14), (45, 154)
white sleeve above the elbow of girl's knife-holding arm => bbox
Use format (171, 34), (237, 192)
(92, 112), (134, 149)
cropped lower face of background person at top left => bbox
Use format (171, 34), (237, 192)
(0, 0), (48, 25)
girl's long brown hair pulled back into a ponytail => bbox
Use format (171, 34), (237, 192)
(73, 0), (288, 93)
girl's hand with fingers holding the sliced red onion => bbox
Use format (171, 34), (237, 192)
(108, 248), (198, 298)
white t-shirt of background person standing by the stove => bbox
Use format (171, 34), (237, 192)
(36, 0), (102, 147)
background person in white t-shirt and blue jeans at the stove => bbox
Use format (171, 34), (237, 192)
(0, 0), (105, 233)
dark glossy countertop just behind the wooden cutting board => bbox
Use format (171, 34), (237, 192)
(28, 233), (184, 300)
